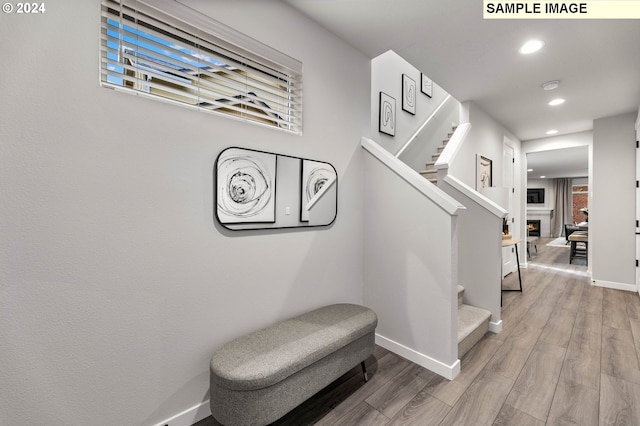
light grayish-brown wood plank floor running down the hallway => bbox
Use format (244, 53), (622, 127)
(197, 240), (640, 426)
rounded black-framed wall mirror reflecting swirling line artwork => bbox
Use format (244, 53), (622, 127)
(213, 147), (338, 231)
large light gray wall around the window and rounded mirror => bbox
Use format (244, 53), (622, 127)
(0, 0), (370, 425)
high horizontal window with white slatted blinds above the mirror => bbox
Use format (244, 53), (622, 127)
(100, 0), (302, 134)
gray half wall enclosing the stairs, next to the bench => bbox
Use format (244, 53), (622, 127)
(364, 148), (461, 379)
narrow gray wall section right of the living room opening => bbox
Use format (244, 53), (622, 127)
(589, 112), (636, 290)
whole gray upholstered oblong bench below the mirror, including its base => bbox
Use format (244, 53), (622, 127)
(210, 304), (378, 426)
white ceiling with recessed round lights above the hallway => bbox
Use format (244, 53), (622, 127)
(282, 0), (640, 141)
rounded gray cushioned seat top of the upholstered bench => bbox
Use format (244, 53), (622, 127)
(211, 304), (378, 390)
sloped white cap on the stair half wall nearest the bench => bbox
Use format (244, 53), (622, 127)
(360, 137), (465, 216)
